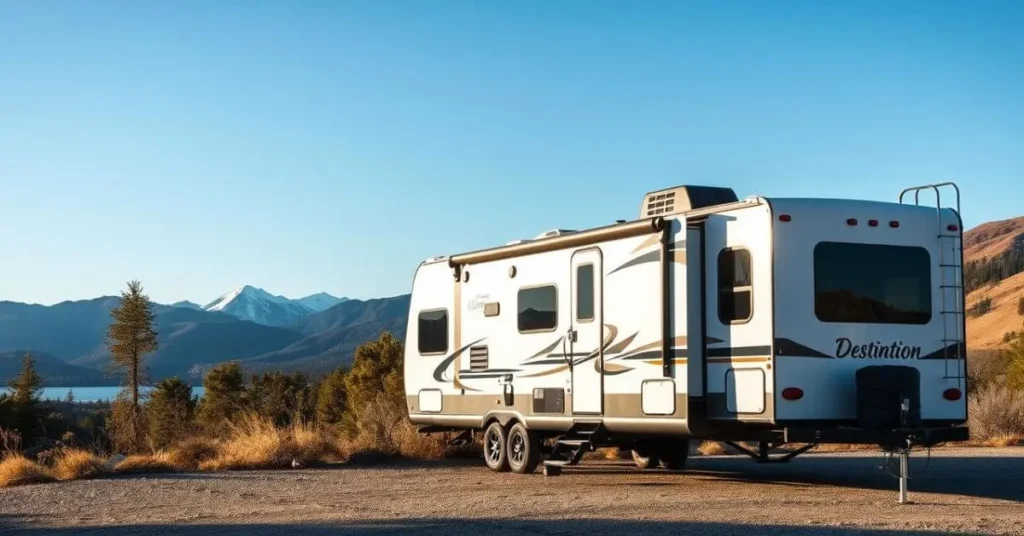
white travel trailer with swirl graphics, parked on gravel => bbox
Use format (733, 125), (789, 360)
(404, 182), (969, 502)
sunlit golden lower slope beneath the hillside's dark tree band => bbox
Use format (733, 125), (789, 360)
(967, 273), (1024, 349)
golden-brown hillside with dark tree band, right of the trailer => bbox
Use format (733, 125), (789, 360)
(964, 216), (1024, 349)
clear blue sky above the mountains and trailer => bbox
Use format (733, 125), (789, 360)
(0, 0), (1024, 303)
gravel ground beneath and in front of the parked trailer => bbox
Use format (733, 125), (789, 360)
(0, 448), (1024, 536)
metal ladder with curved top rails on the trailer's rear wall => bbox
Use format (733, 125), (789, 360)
(899, 182), (967, 390)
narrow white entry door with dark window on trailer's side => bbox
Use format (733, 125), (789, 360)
(568, 248), (604, 415)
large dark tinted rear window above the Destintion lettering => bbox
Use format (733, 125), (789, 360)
(814, 242), (932, 324)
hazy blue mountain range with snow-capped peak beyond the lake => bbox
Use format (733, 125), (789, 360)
(0, 285), (409, 386)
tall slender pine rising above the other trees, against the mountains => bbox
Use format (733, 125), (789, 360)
(106, 281), (158, 449)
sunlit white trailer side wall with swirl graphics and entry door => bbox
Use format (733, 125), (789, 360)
(406, 219), (688, 435)
